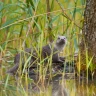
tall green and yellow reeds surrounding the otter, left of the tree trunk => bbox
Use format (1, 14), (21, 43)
(0, 0), (93, 96)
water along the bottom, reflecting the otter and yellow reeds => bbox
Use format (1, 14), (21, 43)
(0, 62), (96, 96)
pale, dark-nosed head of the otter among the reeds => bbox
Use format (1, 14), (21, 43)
(55, 36), (67, 51)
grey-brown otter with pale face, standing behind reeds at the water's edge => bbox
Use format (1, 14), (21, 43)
(7, 36), (66, 75)
